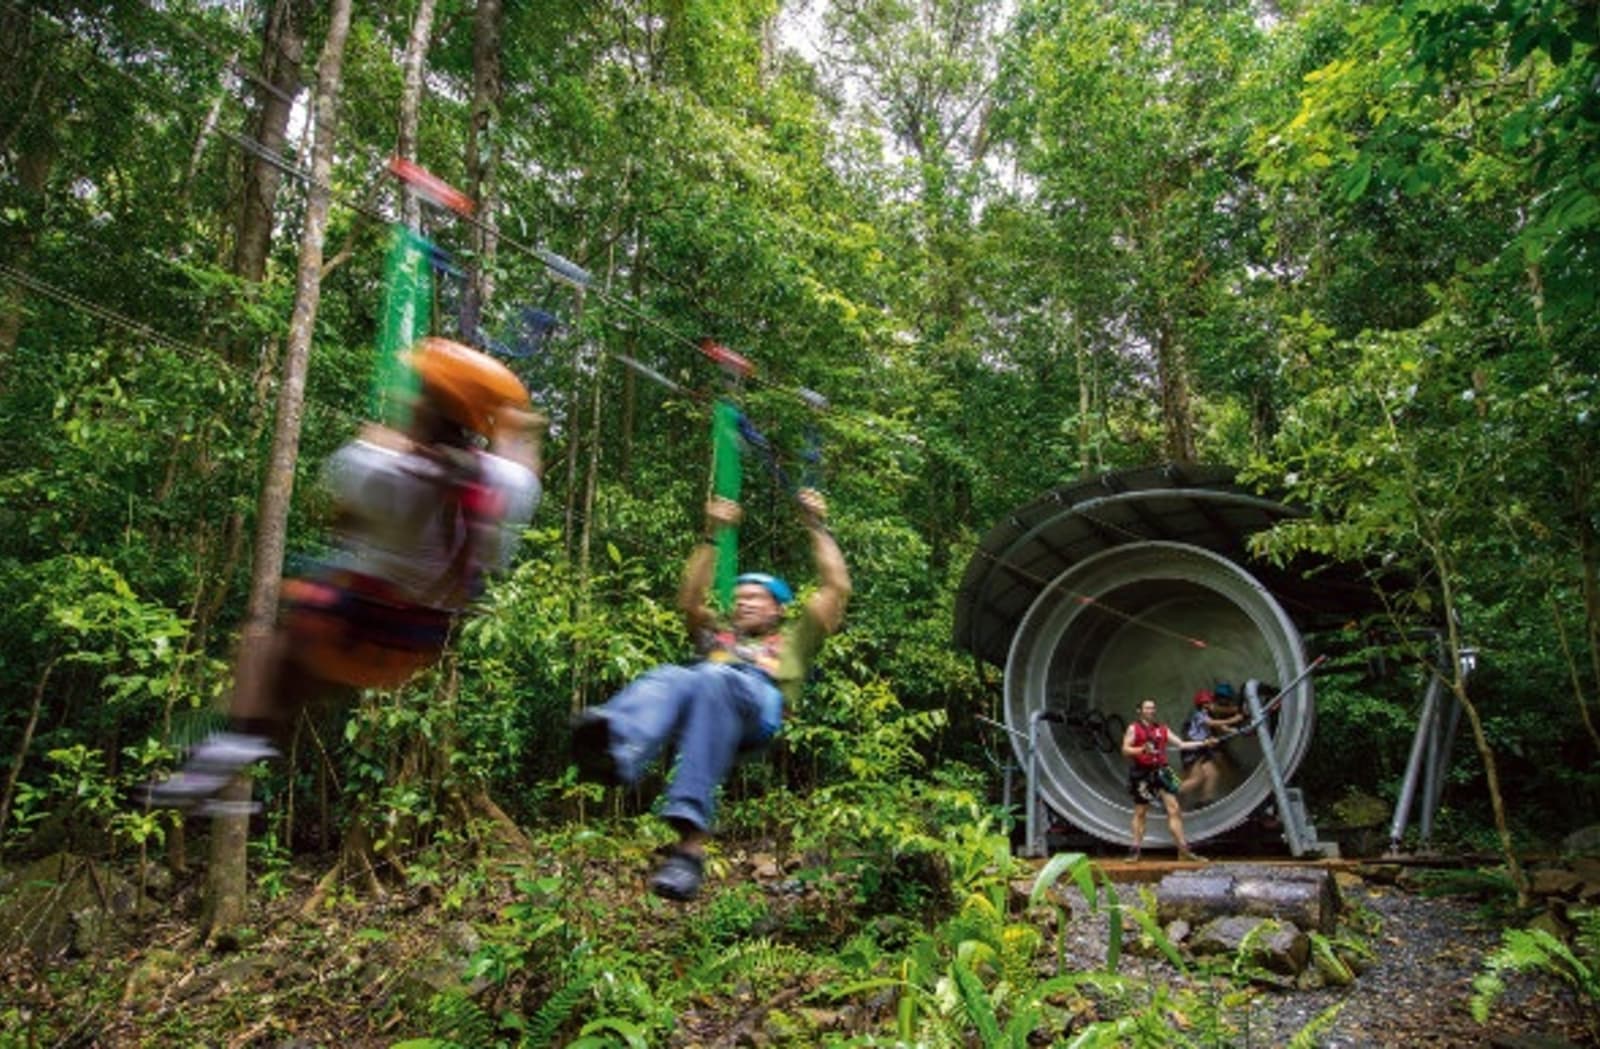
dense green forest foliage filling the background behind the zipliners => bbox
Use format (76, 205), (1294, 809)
(0, 0), (1600, 1038)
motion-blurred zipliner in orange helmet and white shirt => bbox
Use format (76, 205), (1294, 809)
(147, 337), (547, 812)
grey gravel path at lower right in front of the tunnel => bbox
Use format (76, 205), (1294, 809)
(1043, 886), (1595, 1049)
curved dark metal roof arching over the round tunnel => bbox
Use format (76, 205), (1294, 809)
(955, 464), (1376, 667)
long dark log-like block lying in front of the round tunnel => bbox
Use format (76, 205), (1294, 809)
(1155, 864), (1341, 934)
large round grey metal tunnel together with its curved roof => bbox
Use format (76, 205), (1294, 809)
(955, 467), (1371, 844)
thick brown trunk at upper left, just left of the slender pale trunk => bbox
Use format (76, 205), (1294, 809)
(232, 0), (310, 299)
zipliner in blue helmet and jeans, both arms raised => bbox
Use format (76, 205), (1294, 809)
(573, 489), (850, 900)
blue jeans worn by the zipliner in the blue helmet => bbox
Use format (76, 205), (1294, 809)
(597, 662), (784, 830)
